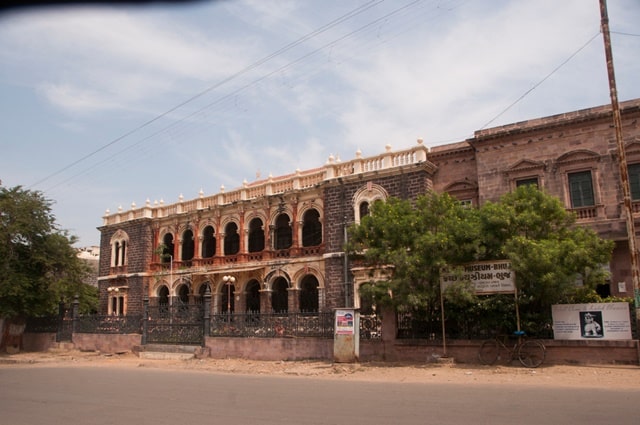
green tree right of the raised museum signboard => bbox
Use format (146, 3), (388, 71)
(479, 185), (614, 330)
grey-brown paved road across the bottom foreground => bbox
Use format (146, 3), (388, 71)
(0, 367), (640, 425)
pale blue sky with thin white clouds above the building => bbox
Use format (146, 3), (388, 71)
(0, 0), (640, 247)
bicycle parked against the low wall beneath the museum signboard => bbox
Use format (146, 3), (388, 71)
(478, 331), (547, 368)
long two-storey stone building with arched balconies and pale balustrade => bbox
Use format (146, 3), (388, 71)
(99, 99), (640, 315)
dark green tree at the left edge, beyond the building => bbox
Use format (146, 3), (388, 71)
(0, 186), (97, 319)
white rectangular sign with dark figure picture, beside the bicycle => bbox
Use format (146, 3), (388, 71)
(551, 303), (631, 340)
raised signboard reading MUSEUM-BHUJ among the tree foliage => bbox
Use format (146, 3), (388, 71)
(440, 260), (516, 295)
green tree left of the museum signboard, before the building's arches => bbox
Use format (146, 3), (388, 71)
(347, 192), (481, 314)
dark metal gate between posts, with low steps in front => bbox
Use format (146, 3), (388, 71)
(143, 304), (204, 345)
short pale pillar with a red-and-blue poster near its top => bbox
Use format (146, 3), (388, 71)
(333, 308), (360, 363)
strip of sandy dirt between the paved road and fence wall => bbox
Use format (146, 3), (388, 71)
(0, 350), (640, 389)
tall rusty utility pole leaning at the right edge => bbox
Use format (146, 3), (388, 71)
(600, 0), (640, 323)
